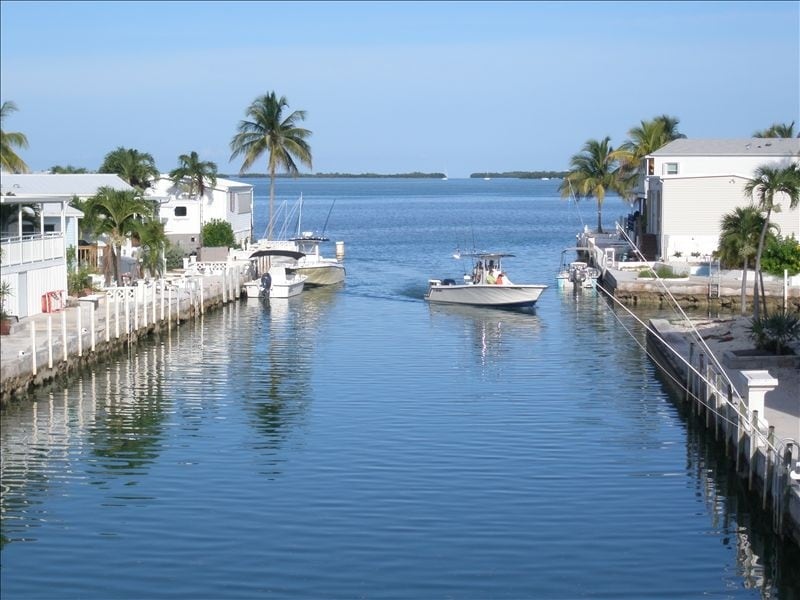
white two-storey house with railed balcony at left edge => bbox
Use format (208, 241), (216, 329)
(0, 173), (133, 317)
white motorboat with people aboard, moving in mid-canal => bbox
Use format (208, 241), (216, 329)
(425, 252), (548, 308)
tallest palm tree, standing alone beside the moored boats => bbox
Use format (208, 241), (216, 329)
(231, 92), (311, 240)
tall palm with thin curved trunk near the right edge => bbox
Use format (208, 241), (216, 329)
(744, 163), (800, 321)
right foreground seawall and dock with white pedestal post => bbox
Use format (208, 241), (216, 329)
(647, 318), (800, 546)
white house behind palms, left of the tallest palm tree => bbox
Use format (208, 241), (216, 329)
(147, 175), (253, 254)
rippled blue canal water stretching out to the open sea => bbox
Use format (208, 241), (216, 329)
(0, 179), (800, 600)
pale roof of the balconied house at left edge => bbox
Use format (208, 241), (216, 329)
(0, 173), (133, 198)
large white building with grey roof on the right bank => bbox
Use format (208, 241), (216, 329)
(637, 138), (800, 260)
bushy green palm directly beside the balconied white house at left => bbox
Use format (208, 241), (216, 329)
(84, 187), (153, 285)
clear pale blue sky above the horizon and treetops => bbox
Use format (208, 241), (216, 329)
(0, 0), (800, 177)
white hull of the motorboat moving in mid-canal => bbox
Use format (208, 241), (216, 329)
(425, 283), (547, 308)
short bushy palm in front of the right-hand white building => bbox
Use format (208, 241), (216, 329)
(717, 206), (765, 314)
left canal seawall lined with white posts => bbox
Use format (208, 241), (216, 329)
(0, 267), (246, 406)
